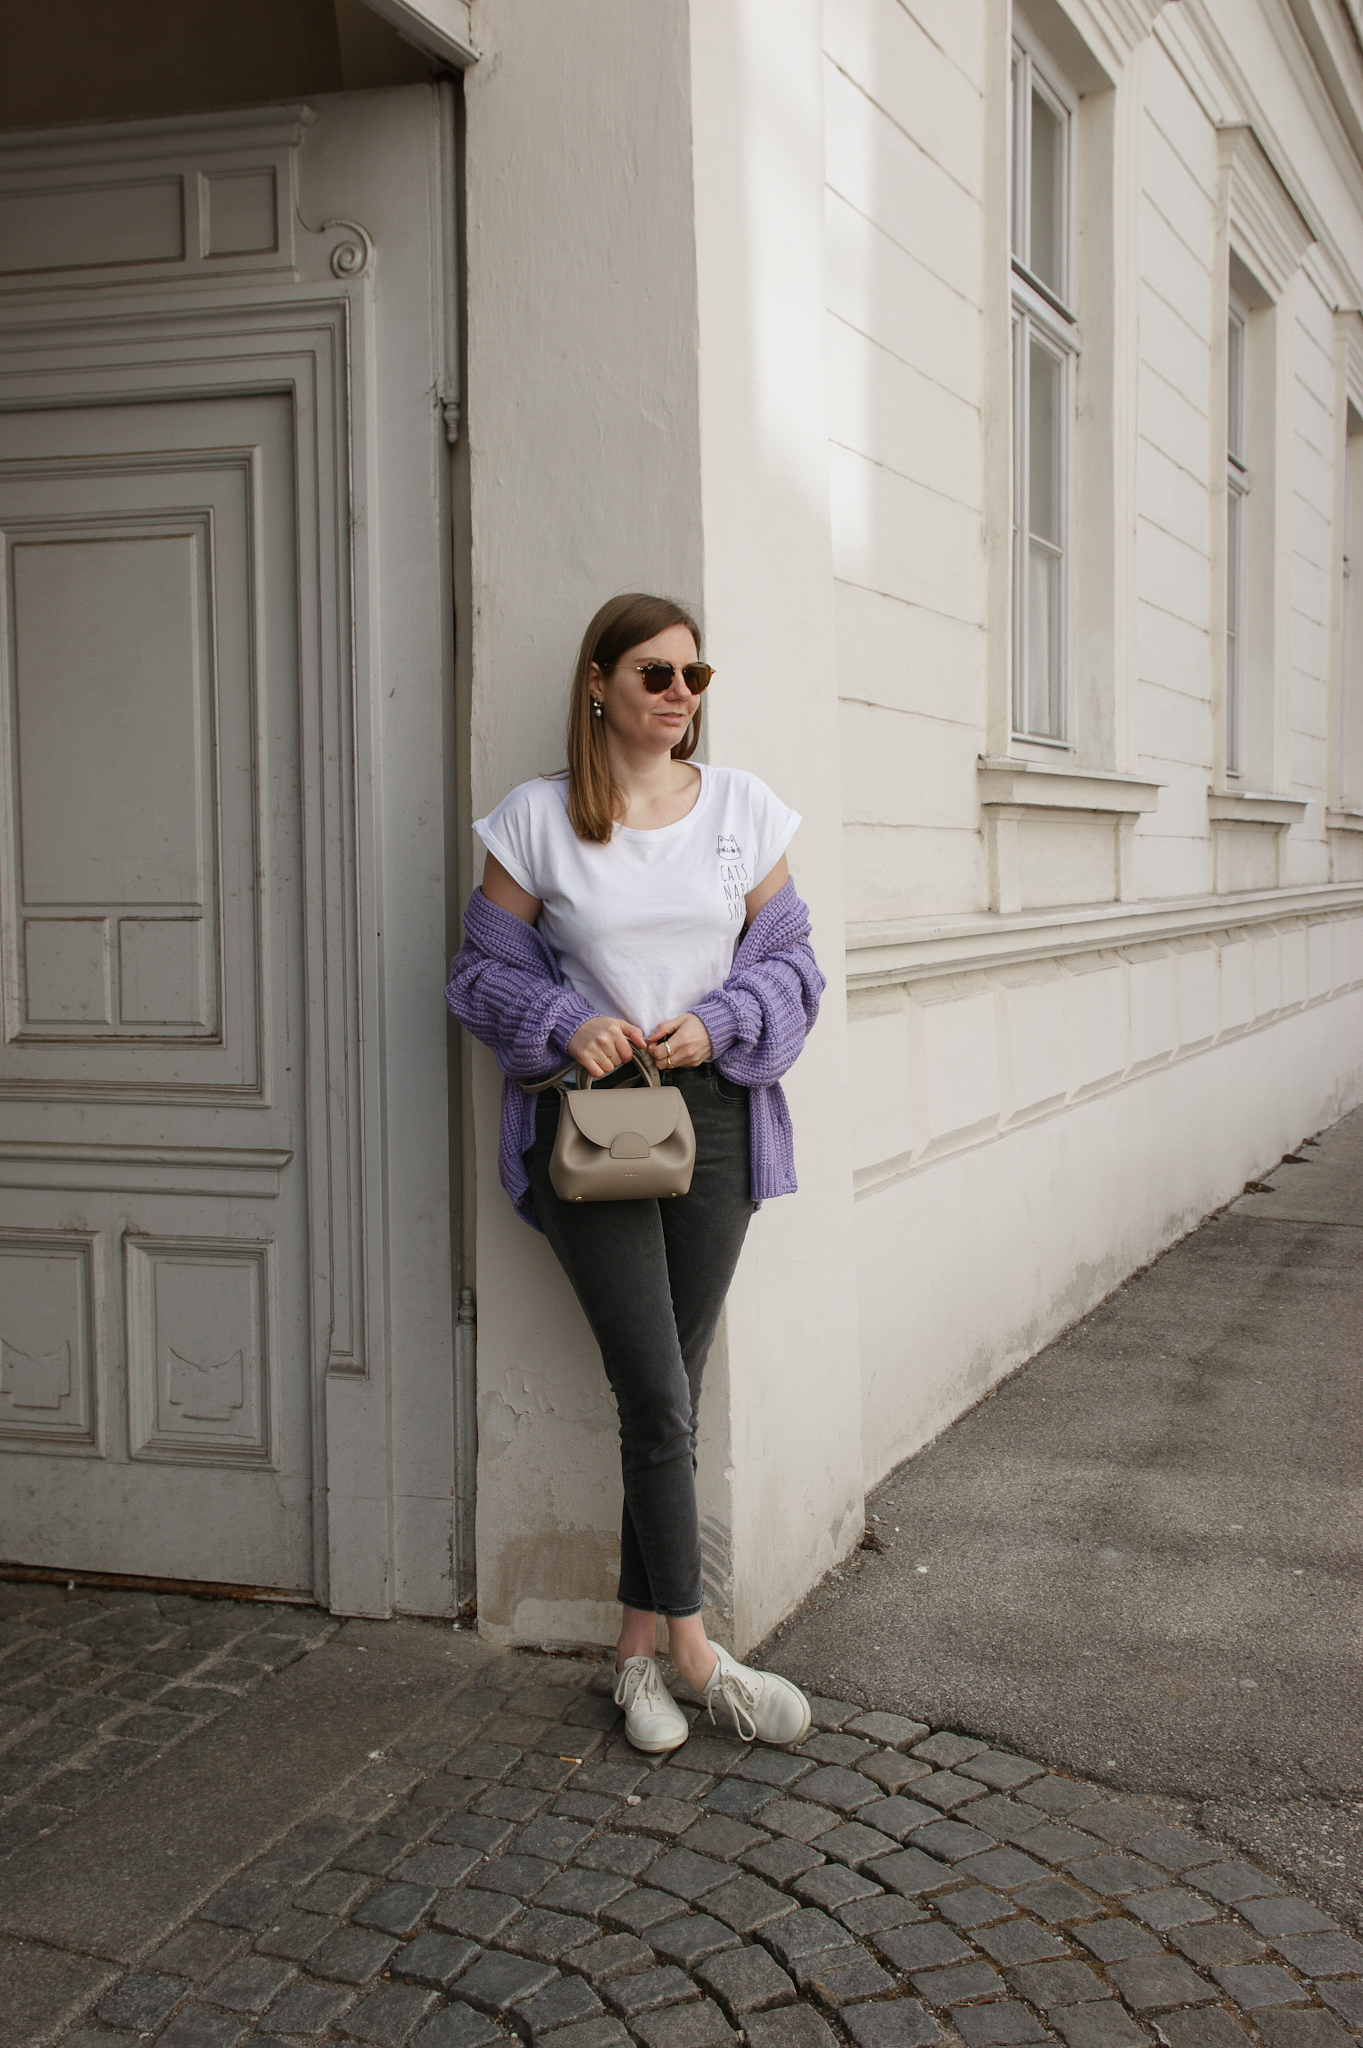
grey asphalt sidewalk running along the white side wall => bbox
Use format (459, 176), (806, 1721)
(767, 1110), (1363, 1927)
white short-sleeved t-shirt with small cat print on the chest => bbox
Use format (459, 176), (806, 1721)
(473, 762), (800, 1032)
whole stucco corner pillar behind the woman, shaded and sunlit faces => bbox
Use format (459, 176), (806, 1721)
(456, 0), (862, 1642)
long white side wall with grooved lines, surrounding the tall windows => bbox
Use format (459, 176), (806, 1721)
(825, 0), (1363, 1507)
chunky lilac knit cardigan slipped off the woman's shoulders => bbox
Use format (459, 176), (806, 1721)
(444, 883), (825, 1231)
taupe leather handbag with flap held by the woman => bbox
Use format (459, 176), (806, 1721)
(520, 1053), (696, 1202)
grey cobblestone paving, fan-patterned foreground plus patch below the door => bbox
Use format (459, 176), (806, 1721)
(0, 1589), (1363, 2048)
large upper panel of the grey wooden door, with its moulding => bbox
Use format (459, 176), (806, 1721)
(0, 425), (270, 1094)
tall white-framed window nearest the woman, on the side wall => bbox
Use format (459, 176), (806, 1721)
(1011, 37), (1079, 745)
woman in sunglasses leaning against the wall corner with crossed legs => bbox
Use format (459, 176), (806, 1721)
(446, 594), (823, 1753)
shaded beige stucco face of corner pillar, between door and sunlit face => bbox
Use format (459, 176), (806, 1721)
(465, 0), (702, 1640)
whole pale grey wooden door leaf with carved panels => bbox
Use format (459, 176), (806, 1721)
(0, 393), (313, 1587)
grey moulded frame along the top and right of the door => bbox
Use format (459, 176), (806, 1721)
(0, 167), (385, 1599)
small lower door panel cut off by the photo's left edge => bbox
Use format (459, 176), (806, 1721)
(0, 1231), (96, 1450)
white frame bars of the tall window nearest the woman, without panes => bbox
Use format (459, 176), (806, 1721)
(1009, 23), (1083, 752)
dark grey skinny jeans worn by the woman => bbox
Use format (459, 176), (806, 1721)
(526, 1061), (753, 1616)
